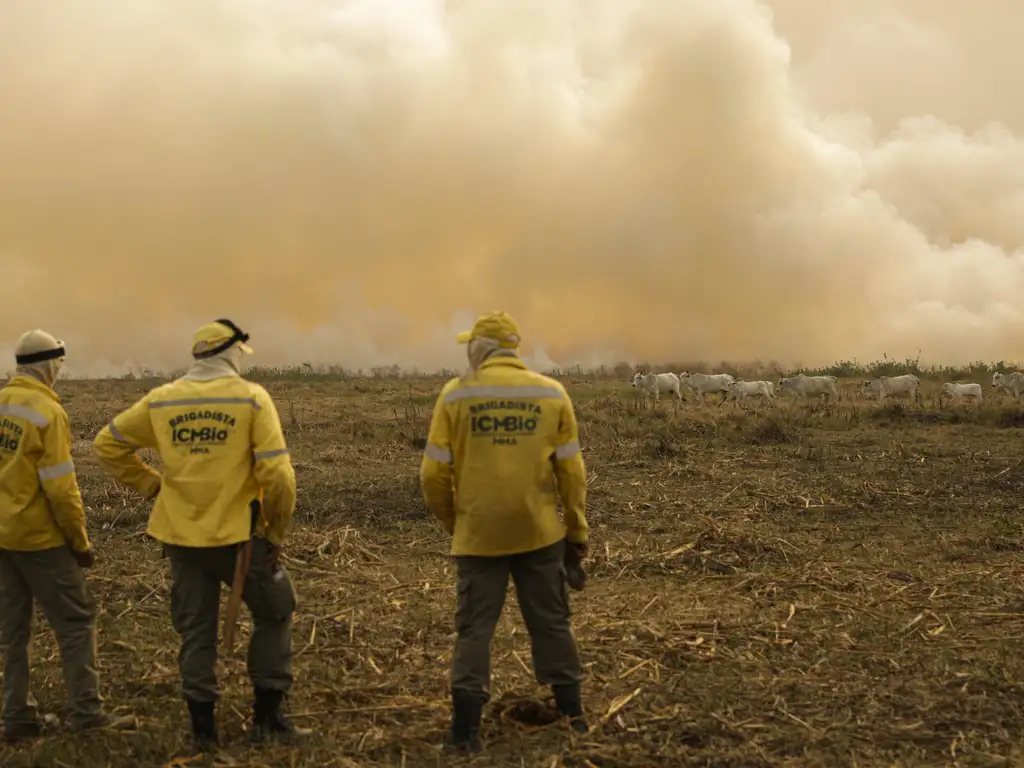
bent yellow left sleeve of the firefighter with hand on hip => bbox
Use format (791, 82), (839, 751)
(92, 396), (161, 499)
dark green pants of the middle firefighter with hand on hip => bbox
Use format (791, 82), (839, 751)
(166, 537), (296, 701)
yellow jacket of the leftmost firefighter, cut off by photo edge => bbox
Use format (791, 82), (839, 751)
(0, 376), (90, 552)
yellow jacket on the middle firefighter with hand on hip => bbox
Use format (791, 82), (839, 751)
(94, 376), (295, 547)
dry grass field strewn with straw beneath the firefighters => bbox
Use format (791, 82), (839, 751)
(0, 375), (1024, 768)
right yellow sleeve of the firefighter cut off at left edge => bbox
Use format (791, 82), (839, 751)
(36, 412), (92, 552)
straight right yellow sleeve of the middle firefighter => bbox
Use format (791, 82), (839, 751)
(252, 387), (296, 546)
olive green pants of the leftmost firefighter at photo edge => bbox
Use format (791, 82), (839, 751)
(0, 547), (102, 727)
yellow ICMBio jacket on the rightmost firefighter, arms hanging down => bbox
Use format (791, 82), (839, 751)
(420, 357), (588, 555)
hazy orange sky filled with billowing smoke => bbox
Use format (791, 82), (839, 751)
(0, 0), (1024, 373)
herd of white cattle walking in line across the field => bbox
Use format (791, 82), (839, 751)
(633, 371), (1024, 406)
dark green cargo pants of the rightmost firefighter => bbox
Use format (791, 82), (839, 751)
(452, 541), (583, 701)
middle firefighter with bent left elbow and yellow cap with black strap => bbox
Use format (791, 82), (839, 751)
(95, 319), (309, 750)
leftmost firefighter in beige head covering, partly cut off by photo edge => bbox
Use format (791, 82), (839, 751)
(0, 330), (134, 741)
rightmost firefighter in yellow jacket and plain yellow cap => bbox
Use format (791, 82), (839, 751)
(420, 312), (588, 754)
